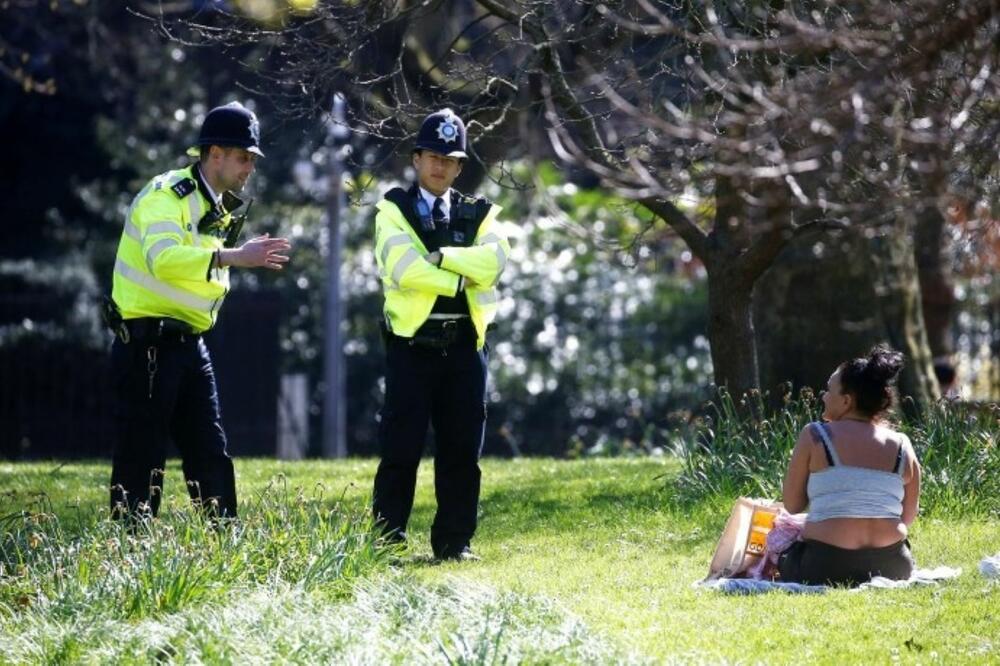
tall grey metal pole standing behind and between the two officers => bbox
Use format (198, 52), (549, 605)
(323, 93), (349, 458)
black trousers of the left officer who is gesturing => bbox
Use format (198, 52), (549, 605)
(111, 336), (236, 517)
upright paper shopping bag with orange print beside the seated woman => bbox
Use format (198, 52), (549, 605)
(705, 497), (783, 580)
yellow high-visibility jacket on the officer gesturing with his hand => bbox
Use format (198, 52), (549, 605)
(111, 165), (230, 333)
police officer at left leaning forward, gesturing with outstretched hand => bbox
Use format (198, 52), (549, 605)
(106, 102), (290, 517)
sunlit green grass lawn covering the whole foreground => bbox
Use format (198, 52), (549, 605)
(0, 459), (1000, 664)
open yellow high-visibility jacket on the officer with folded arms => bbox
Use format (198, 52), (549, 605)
(375, 191), (510, 349)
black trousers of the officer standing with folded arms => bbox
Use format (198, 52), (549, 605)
(373, 335), (486, 557)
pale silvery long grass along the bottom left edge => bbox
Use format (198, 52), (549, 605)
(0, 575), (634, 664)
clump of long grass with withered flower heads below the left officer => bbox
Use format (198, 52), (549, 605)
(0, 474), (390, 620)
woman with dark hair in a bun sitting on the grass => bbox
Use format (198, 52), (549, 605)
(778, 346), (920, 586)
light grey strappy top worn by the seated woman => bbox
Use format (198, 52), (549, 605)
(806, 423), (906, 523)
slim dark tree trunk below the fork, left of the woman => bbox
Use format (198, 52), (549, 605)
(708, 268), (760, 396)
